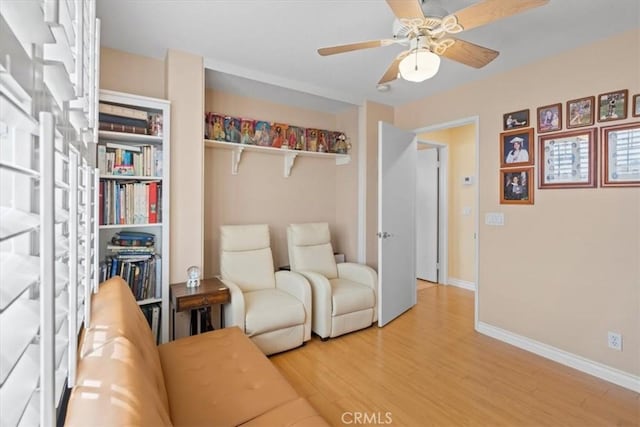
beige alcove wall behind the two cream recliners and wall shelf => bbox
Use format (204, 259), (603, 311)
(204, 89), (357, 276)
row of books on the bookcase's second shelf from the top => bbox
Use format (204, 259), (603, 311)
(97, 142), (162, 177)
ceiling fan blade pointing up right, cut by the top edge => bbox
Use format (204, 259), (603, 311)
(454, 0), (549, 30)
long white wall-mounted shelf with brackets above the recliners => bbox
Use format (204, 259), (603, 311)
(204, 139), (351, 178)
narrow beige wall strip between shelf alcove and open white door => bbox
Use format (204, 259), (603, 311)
(363, 101), (393, 270)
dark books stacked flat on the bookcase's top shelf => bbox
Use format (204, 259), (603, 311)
(98, 102), (162, 136)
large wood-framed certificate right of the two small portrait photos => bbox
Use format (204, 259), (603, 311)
(538, 128), (597, 188)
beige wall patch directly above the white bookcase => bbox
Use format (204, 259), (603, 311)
(100, 47), (165, 99)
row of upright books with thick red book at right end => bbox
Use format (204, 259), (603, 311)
(98, 179), (162, 225)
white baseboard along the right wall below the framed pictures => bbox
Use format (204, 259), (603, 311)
(477, 322), (640, 393)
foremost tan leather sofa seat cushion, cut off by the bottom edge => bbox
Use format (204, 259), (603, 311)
(242, 397), (327, 427)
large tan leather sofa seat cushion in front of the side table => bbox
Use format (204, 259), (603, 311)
(158, 327), (298, 426)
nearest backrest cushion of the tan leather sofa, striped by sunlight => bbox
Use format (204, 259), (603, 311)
(64, 336), (171, 427)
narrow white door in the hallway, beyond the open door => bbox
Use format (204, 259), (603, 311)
(416, 148), (439, 283)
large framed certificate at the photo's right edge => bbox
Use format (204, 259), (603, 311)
(600, 122), (640, 187)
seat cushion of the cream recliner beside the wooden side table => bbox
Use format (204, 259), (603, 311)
(244, 289), (305, 337)
